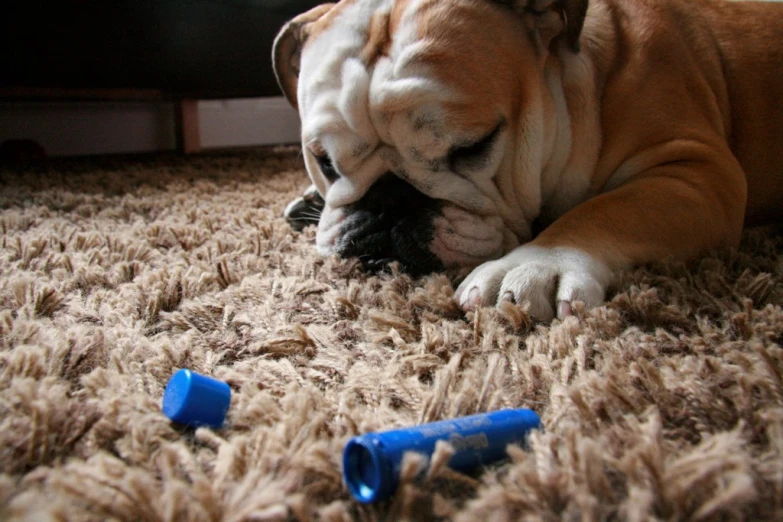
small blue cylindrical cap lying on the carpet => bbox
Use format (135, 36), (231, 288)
(163, 369), (231, 428)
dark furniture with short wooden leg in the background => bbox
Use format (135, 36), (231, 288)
(0, 0), (321, 152)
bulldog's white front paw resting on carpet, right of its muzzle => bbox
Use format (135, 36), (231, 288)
(454, 245), (612, 321)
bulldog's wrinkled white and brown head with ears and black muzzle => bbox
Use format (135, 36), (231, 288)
(273, 0), (587, 272)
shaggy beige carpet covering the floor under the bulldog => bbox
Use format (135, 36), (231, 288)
(0, 148), (783, 522)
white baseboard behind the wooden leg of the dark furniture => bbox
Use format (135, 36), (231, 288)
(0, 97), (299, 156)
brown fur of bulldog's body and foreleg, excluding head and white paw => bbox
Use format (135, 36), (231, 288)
(535, 0), (783, 266)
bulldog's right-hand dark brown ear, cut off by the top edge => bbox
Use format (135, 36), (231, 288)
(496, 0), (589, 53)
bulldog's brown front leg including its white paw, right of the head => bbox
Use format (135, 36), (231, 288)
(455, 154), (747, 321)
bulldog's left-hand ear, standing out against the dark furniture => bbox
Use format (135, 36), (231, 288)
(272, 4), (334, 109)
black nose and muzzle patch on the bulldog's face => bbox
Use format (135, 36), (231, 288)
(337, 174), (443, 276)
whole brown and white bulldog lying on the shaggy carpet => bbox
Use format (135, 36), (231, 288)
(273, 0), (783, 321)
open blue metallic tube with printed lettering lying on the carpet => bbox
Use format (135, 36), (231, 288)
(343, 409), (541, 503)
